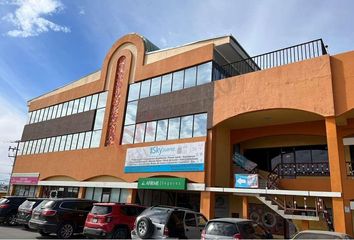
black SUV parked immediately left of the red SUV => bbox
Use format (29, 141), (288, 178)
(29, 198), (95, 238)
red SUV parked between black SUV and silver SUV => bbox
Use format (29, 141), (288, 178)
(84, 203), (145, 239)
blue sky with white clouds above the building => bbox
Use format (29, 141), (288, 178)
(0, 0), (354, 184)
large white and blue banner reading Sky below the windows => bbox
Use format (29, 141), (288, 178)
(124, 142), (205, 173)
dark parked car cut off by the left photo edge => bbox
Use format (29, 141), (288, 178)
(0, 196), (26, 225)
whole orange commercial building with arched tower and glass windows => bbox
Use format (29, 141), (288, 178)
(11, 34), (354, 236)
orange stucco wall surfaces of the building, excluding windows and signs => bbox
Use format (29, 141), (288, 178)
(13, 34), (354, 234)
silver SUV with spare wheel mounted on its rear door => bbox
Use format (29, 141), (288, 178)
(131, 206), (207, 239)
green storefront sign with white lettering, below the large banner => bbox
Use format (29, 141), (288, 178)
(138, 178), (187, 190)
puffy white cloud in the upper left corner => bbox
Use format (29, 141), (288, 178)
(2, 0), (70, 37)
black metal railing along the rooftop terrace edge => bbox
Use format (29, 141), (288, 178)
(221, 39), (327, 79)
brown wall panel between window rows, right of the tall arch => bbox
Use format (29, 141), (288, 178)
(136, 83), (214, 128)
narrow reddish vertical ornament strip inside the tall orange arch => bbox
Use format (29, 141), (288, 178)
(106, 56), (126, 146)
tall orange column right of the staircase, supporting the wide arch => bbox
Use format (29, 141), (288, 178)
(325, 117), (347, 232)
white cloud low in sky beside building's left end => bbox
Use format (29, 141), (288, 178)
(0, 97), (26, 183)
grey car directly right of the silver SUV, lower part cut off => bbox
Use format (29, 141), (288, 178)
(202, 218), (273, 240)
